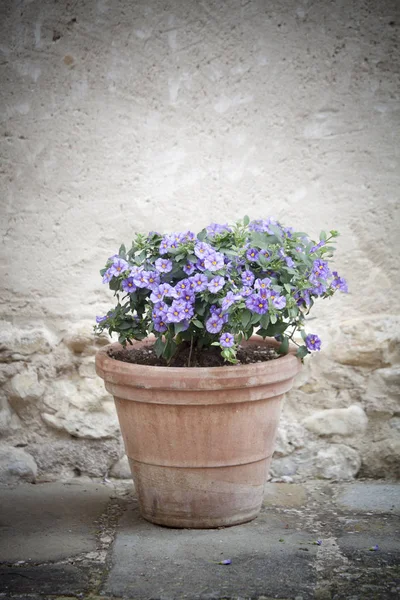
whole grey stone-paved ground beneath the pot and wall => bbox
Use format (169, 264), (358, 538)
(0, 478), (400, 600)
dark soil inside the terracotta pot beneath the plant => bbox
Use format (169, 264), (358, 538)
(108, 345), (279, 367)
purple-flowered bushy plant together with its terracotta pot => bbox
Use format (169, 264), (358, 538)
(96, 217), (347, 527)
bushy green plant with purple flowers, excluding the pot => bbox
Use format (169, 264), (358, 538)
(95, 216), (347, 366)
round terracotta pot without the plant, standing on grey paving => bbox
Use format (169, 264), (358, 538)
(96, 339), (301, 528)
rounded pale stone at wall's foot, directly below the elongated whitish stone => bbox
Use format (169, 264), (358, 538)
(313, 444), (361, 479)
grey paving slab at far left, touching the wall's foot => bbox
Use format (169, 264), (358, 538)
(0, 481), (113, 563)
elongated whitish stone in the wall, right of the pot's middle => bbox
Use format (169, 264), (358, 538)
(303, 404), (368, 436)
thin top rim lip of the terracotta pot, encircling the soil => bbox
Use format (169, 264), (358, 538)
(96, 336), (302, 377)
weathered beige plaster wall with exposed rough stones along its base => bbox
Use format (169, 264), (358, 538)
(0, 0), (400, 481)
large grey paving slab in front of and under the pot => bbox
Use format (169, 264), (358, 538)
(103, 496), (317, 600)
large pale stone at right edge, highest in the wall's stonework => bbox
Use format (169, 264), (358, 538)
(331, 314), (400, 369)
